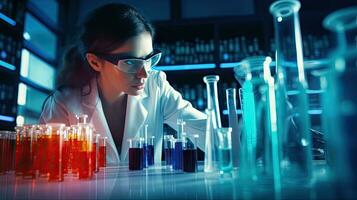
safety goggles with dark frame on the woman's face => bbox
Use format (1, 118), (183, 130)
(95, 49), (161, 73)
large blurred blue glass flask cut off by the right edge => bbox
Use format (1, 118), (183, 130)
(322, 6), (357, 194)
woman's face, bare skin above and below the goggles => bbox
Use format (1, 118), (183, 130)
(89, 32), (153, 96)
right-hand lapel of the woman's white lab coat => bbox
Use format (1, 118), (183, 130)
(120, 88), (148, 160)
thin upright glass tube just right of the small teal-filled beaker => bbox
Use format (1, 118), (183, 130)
(226, 88), (240, 168)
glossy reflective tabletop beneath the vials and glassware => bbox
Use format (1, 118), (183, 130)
(0, 163), (350, 199)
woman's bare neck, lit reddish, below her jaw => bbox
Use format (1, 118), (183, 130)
(97, 76), (125, 106)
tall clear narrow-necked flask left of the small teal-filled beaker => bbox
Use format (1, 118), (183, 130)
(203, 75), (221, 172)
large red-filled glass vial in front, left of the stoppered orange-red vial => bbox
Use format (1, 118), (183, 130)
(47, 123), (65, 181)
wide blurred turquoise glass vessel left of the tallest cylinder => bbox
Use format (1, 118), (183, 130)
(234, 56), (279, 180)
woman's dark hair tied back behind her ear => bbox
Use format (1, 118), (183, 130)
(56, 3), (154, 93)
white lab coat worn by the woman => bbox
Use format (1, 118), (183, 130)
(39, 71), (207, 165)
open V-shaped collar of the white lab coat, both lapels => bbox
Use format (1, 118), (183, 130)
(82, 79), (149, 161)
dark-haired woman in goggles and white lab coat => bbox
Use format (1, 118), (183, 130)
(39, 4), (206, 165)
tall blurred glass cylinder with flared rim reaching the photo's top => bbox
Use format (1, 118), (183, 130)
(270, 0), (312, 183)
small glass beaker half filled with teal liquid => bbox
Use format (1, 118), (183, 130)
(217, 127), (233, 174)
